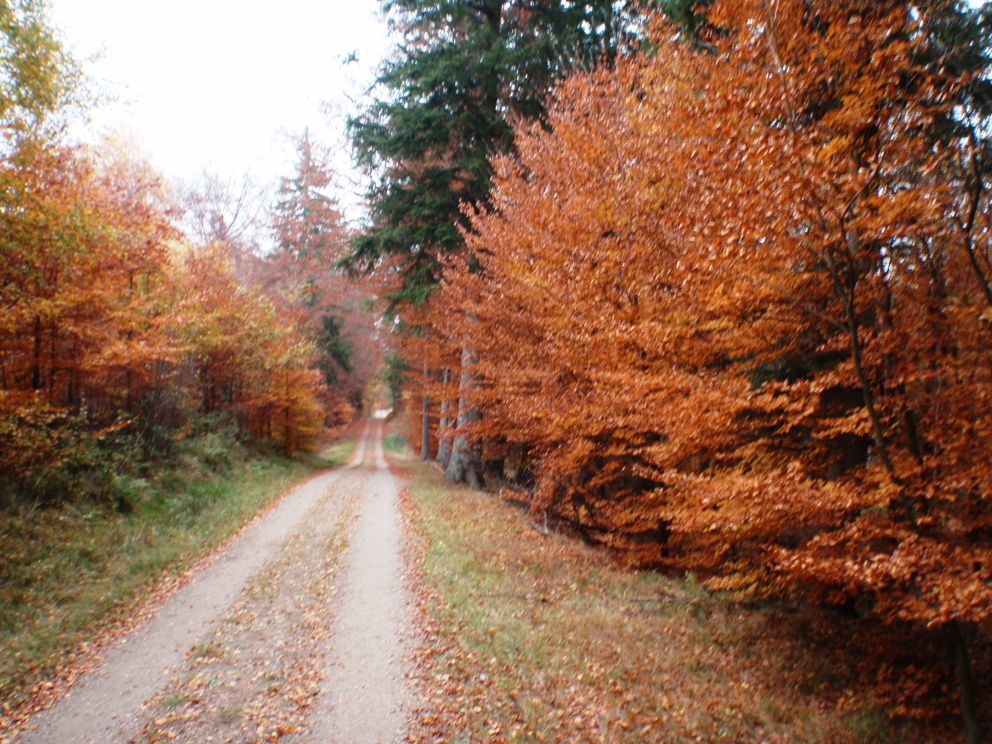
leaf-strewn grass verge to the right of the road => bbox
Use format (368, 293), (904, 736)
(398, 452), (960, 744)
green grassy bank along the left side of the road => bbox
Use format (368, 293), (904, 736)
(0, 435), (354, 718)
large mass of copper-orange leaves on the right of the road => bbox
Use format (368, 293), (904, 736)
(435, 0), (992, 640)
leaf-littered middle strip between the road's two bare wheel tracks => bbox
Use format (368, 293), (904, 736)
(136, 456), (364, 742)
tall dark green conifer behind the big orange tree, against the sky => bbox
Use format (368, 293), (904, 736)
(347, 0), (639, 309)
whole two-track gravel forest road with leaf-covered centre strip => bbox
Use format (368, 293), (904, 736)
(19, 422), (413, 744)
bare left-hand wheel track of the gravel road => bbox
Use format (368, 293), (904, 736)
(18, 426), (371, 744)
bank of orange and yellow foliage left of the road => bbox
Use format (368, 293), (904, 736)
(0, 140), (334, 491)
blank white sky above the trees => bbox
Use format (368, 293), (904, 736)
(50, 0), (390, 212)
